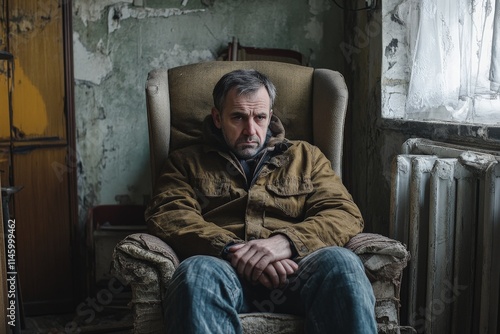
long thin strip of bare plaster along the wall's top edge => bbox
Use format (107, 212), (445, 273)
(108, 4), (205, 33)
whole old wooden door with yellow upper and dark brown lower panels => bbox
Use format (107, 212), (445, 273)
(0, 0), (76, 315)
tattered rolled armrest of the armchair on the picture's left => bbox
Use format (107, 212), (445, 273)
(111, 233), (179, 333)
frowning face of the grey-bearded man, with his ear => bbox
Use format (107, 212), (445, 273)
(212, 87), (272, 159)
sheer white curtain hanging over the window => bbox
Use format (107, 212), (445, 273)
(406, 0), (500, 123)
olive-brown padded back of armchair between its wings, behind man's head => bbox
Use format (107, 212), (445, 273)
(168, 61), (314, 150)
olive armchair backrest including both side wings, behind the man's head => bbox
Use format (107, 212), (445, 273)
(146, 61), (348, 185)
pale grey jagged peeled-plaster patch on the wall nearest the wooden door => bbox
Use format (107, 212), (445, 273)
(73, 32), (113, 85)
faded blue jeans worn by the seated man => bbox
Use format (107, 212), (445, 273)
(164, 247), (377, 334)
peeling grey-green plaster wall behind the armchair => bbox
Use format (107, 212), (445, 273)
(73, 0), (343, 223)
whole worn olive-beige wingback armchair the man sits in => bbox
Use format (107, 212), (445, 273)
(112, 61), (409, 334)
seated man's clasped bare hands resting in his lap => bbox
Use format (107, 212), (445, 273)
(227, 234), (299, 289)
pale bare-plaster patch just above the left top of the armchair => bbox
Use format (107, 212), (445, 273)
(149, 44), (215, 68)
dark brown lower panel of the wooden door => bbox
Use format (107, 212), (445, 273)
(13, 147), (73, 313)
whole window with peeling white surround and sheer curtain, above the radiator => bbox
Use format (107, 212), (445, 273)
(382, 0), (500, 125)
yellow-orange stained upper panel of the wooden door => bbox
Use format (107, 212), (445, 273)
(9, 0), (66, 140)
